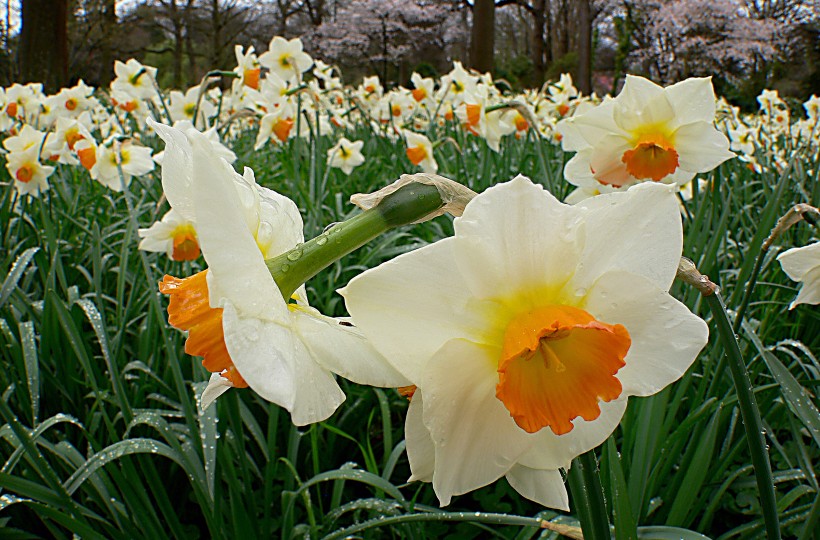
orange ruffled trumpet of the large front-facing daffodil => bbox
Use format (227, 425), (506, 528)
(495, 305), (632, 435)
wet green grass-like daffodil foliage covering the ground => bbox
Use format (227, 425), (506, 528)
(0, 119), (820, 539)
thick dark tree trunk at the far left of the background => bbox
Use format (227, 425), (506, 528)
(20, 0), (68, 92)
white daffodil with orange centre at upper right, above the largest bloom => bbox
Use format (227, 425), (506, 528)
(557, 75), (734, 200)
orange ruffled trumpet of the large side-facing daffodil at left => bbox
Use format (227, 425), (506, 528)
(159, 270), (248, 388)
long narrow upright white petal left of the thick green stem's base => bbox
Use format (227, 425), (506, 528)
(191, 135), (288, 324)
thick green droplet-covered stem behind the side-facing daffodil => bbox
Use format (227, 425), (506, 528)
(265, 183), (444, 300)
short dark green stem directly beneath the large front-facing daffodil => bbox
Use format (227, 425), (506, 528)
(568, 450), (612, 540)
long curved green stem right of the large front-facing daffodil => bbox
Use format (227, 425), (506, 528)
(704, 292), (780, 540)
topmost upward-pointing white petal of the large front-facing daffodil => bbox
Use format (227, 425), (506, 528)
(454, 176), (583, 301)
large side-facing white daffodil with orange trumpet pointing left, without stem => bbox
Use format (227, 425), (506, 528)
(152, 123), (407, 425)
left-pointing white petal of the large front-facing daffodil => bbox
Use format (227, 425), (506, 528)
(339, 238), (486, 384)
